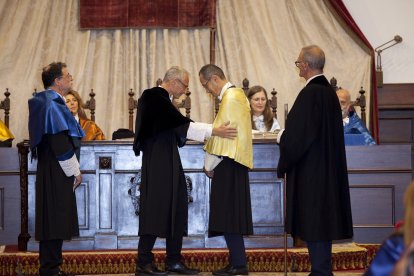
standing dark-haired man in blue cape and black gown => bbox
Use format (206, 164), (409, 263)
(29, 62), (84, 276)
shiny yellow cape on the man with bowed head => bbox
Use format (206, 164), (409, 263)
(204, 88), (253, 169)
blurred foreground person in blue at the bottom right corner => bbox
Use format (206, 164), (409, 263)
(365, 181), (414, 276)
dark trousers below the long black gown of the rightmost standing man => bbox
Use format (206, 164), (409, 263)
(306, 241), (333, 276)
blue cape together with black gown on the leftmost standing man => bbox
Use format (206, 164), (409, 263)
(29, 90), (84, 241)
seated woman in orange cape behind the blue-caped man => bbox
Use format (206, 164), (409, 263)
(65, 90), (105, 141)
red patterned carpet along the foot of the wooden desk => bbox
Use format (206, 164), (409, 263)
(0, 244), (379, 276)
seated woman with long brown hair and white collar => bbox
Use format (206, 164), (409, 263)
(247, 85), (280, 132)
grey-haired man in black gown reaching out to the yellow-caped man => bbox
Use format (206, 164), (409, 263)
(133, 66), (237, 275)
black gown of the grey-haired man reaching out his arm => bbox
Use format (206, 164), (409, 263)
(133, 87), (191, 237)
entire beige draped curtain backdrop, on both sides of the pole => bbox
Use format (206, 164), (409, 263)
(0, 0), (370, 144)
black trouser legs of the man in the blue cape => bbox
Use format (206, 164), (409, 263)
(39, 240), (63, 276)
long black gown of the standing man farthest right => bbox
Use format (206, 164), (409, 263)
(278, 76), (353, 241)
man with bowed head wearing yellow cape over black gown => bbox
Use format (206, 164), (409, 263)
(199, 64), (253, 275)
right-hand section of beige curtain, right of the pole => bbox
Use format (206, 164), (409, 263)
(216, 0), (371, 127)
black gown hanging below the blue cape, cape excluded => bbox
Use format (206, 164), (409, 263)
(35, 132), (79, 241)
